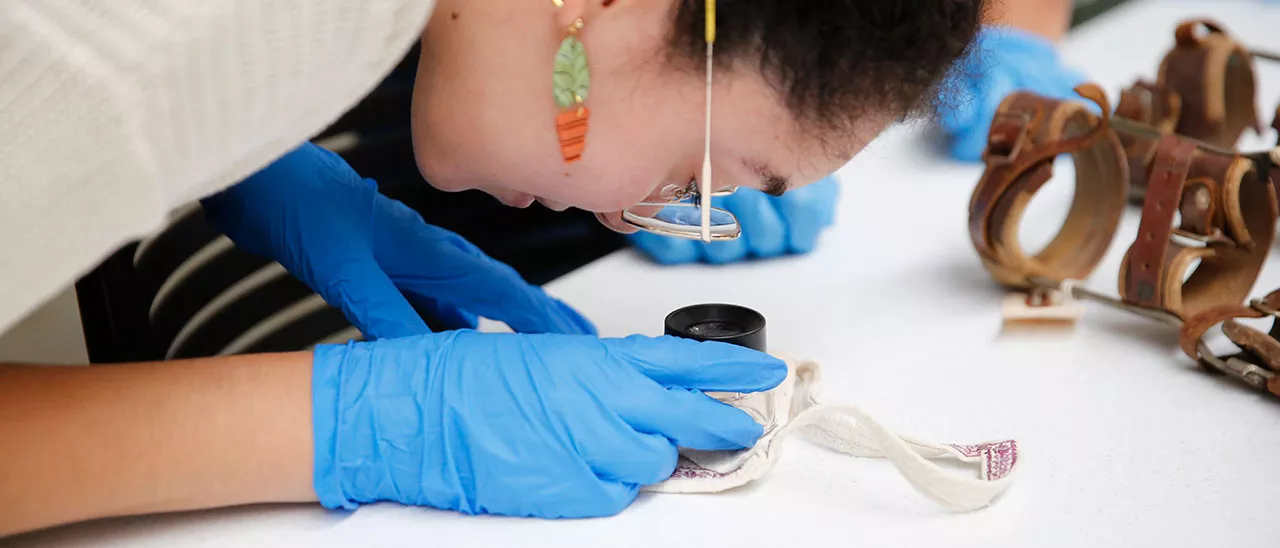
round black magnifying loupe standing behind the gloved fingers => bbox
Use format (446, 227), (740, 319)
(663, 302), (768, 352)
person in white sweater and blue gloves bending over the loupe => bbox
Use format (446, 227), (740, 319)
(0, 0), (983, 535)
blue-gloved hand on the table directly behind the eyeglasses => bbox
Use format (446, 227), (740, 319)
(628, 175), (840, 265)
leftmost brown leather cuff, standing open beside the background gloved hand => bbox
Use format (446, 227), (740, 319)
(969, 83), (1129, 287)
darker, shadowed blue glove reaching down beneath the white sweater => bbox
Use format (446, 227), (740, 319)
(202, 143), (595, 338)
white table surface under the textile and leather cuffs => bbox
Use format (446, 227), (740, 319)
(12, 0), (1280, 548)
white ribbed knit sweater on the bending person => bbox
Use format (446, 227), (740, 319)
(0, 0), (435, 332)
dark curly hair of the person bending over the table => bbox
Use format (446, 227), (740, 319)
(671, 0), (986, 143)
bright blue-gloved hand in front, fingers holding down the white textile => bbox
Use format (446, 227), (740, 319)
(311, 330), (787, 517)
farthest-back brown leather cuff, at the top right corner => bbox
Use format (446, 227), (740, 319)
(1157, 19), (1262, 147)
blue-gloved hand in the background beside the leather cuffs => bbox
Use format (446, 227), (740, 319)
(938, 26), (1097, 161)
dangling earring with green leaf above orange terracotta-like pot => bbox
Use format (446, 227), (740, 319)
(552, 16), (591, 164)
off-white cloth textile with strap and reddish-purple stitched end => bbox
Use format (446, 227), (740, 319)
(645, 360), (1018, 511)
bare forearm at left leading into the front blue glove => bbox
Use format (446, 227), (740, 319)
(0, 352), (315, 536)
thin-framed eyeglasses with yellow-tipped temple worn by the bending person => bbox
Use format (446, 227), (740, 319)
(622, 0), (742, 242)
